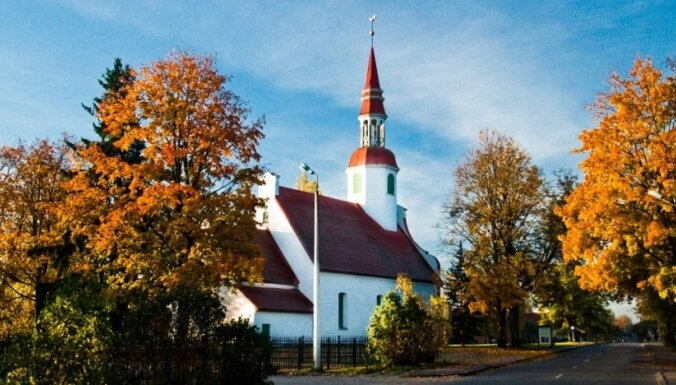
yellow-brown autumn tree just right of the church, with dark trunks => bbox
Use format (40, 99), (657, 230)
(441, 131), (543, 347)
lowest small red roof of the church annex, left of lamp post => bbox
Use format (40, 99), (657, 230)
(239, 286), (312, 313)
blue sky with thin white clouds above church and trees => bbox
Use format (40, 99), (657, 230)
(0, 0), (676, 304)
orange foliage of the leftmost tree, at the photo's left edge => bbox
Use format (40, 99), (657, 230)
(0, 140), (70, 338)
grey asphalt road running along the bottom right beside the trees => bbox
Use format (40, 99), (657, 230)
(452, 343), (656, 385)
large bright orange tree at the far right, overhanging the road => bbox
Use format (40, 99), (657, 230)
(558, 59), (676, 343)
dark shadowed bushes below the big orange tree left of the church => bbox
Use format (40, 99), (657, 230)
(108, 288), (272, 385)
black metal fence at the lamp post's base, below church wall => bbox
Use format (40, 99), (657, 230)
(271, 336), (372, 370)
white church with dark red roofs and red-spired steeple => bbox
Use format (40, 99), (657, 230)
(224, 41), (440, 337)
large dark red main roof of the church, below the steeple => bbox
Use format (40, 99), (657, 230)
(277, 187), (435, 282)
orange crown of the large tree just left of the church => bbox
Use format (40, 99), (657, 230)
(68, 52), (263, 318)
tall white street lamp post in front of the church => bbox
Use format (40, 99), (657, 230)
(300, 163), (322, 370)
